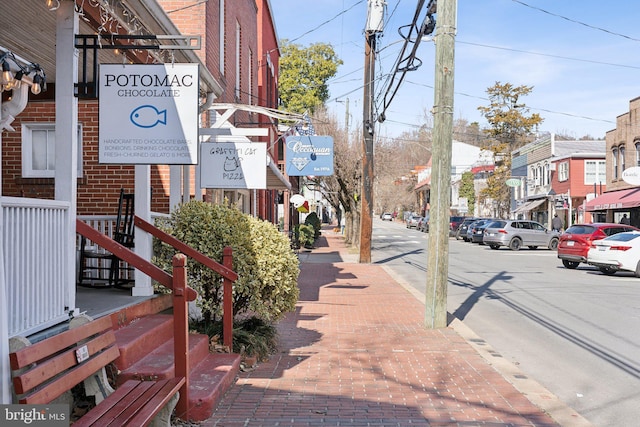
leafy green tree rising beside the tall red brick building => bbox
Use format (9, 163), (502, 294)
(278, 40), (342, 113)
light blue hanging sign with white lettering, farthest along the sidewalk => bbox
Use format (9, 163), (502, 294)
(285, 135), (333, 176)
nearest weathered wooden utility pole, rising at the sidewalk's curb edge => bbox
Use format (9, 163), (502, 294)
(425, 0), (457, 329)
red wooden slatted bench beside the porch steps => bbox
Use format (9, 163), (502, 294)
(9, 316), (185, 427)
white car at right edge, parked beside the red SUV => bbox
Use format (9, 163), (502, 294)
(587, 231), (640, 277)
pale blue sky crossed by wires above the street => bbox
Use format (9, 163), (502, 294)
(270, 0), (640, 144)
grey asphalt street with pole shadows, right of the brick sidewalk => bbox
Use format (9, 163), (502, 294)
(372, 220), (640, 427)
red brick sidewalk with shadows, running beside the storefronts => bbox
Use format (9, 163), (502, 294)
(202, 229), (569, 427)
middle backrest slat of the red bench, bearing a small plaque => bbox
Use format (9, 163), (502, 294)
(13, 330), (118, 394)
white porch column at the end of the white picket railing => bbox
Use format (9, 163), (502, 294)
(55, 1), (79, 318)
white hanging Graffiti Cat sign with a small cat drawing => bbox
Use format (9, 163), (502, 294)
(200, 142), (267, 190)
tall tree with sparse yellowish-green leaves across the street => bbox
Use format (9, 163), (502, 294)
(478, 82), (543, 217)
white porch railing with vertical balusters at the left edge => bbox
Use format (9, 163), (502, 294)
(1, 197), (70, 337)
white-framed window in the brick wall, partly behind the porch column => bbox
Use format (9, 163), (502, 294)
(22, 123), (82, 178)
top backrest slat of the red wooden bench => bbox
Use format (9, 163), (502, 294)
(9, 316), (112, 370)
